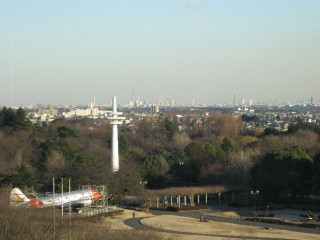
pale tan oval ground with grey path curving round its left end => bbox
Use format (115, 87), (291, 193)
(124, 211), (320, 240)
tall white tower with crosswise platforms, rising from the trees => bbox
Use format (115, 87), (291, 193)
(108, 96), (125, 172)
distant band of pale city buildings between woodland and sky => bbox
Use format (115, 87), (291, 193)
(23, 103), (320, 132)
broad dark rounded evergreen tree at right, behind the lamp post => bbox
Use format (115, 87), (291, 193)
(251, 147), (313, 199)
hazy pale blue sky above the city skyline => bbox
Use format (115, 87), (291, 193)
(0, 0), (320, 105)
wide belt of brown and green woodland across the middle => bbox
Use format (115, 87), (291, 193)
(0, 108), (320, 200)
